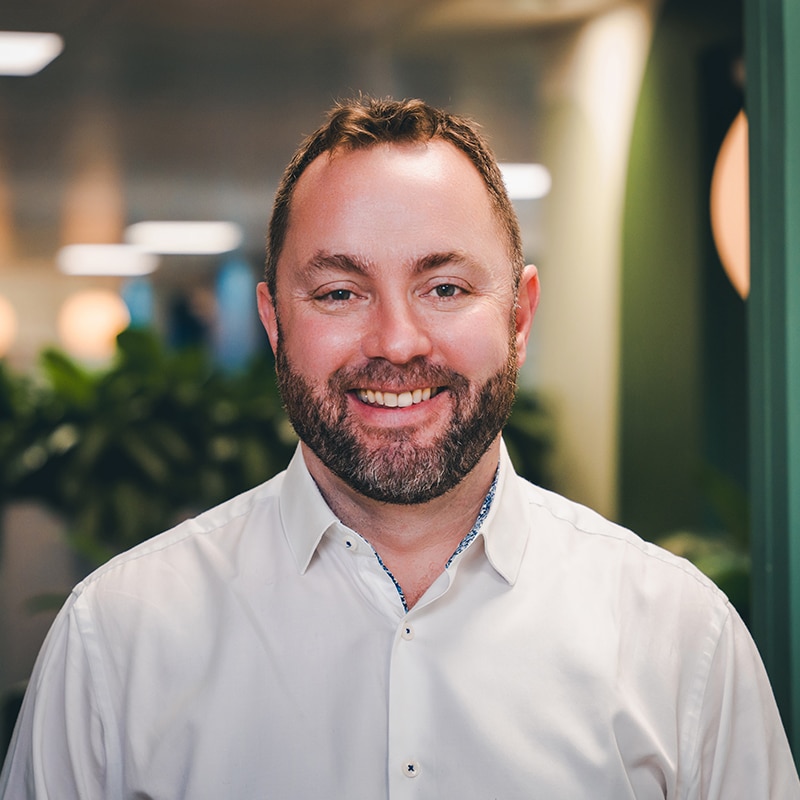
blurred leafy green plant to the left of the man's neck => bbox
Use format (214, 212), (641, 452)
(0, 330), (296, 564)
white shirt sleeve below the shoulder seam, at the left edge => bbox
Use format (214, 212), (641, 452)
(0, 597), (115, 800)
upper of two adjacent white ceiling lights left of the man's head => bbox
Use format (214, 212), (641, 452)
(125, 221), (242, 255)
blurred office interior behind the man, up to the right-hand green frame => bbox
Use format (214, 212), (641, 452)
(0, 0), (747, 752)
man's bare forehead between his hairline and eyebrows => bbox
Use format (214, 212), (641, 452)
(281, 139), (506, 268)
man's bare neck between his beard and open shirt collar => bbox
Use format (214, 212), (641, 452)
(302, 437), (500, 608)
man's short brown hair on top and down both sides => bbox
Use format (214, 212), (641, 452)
(265, 96), (523, 301)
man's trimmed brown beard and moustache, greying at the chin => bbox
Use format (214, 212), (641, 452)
(276, 334), (518, 505)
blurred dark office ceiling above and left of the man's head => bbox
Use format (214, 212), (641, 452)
(0, 0), (618, 269)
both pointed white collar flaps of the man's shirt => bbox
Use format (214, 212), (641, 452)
(280, 442), (529, 585)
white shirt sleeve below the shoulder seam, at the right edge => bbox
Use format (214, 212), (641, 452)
(688, 608), (800, 800)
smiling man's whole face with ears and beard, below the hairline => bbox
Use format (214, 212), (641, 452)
(259, 140), (535, 503)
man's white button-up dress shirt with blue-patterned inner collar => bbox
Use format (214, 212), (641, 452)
(0, 440), (800, 800)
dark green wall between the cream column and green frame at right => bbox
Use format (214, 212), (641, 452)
(619, 0), (747, 538)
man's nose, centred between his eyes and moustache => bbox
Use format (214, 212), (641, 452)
(362, 298), (431, 364)
